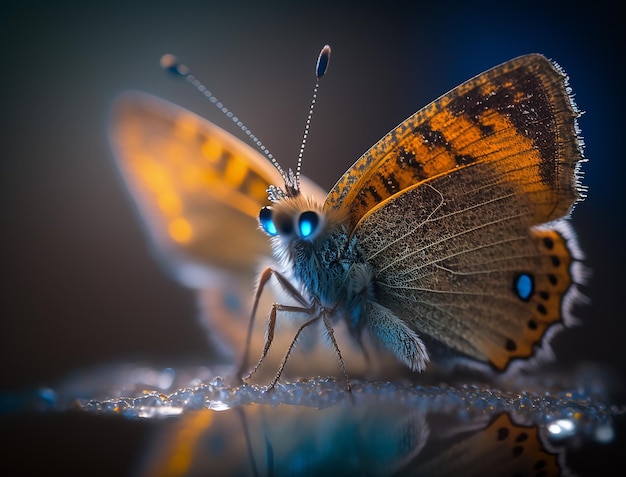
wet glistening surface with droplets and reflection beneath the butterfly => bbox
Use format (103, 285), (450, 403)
(2, 364), (625, 476)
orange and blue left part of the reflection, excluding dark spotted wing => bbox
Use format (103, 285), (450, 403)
(137, 403), (426, 477)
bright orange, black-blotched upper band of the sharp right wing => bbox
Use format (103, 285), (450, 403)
(326, 54), (582, 227)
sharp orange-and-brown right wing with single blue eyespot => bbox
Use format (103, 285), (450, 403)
(327, 55), (583, 370)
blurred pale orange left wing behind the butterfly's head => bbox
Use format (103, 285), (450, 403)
(110, 93), (280, 287)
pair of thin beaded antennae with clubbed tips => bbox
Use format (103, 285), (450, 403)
(161, 45), (330, 197)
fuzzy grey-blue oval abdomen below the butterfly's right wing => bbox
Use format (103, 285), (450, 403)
(366, 301), (429, 372)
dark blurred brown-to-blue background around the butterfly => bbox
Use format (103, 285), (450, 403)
(0, 1), (626, 472)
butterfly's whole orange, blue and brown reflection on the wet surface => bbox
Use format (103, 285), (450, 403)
(138, 402), (569, 477)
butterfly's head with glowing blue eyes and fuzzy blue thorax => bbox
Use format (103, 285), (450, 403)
(260, 196), (374, 328)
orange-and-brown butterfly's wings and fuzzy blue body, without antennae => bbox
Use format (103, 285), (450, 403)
(111, 45), (583, 386)
